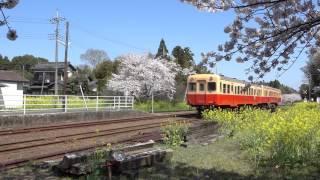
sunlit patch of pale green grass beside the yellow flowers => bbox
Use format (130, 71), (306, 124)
(172, 140), (253, 176)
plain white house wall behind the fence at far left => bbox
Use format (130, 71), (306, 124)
(0, 82), (23, 108)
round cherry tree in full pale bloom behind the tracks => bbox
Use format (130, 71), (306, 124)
(108, 54), (191, 99)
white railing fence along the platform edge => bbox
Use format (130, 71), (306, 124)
(0, 94), (134, 115)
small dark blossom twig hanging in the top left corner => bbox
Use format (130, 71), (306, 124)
(0, 0), (19, 41)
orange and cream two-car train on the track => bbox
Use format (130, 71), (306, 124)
(187, 74), (281, 111)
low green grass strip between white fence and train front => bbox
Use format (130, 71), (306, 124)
(134, 101), (190, 112)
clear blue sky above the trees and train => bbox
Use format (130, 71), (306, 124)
(0, 0), (306, 89)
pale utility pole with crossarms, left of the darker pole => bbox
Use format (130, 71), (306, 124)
(50, 11), (65, 95)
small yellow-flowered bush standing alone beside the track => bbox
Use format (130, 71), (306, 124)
(161, 120), (189, 147)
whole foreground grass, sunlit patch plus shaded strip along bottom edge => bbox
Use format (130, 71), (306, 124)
(139, 138), (319, 180)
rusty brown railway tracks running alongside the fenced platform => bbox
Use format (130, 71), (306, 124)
(0, 113), (199, 168)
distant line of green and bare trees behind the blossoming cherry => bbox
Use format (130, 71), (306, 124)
(0, 39), (295, 102)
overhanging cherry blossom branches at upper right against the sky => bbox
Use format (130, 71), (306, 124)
(181, 0), (320, 81)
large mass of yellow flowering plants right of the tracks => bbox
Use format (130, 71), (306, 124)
(203, 103), (320, 167)
